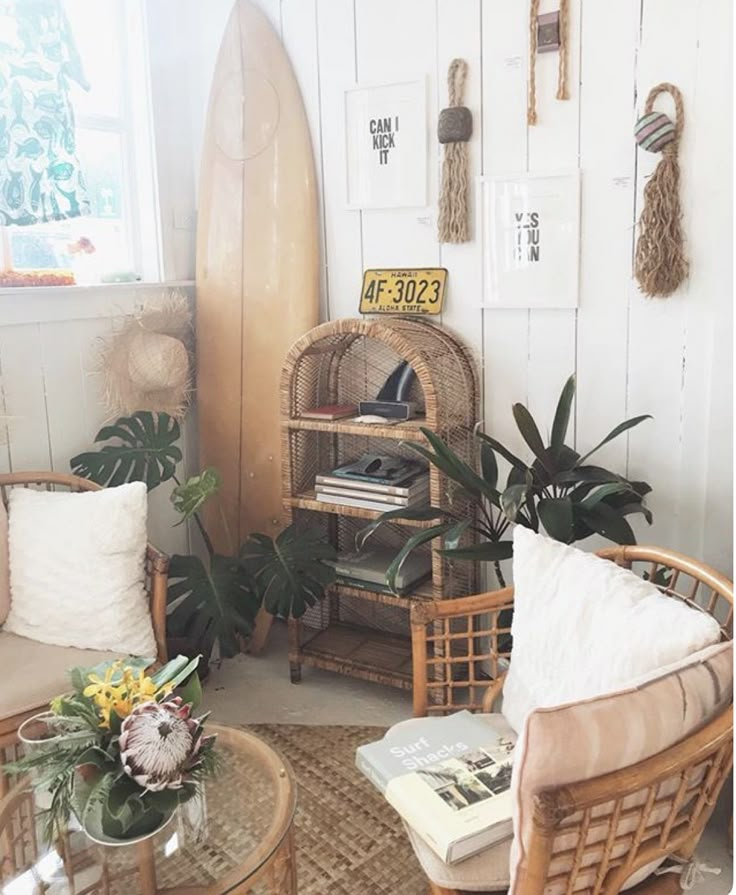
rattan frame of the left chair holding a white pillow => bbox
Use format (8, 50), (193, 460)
(0, 472), (169, 797)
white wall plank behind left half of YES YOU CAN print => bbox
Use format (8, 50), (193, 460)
(481, 0), (529, 451)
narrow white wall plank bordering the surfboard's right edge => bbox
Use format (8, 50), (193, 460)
(281, 0), (329, 320)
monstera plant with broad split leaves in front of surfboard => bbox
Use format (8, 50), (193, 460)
(71, 411), (335, 657)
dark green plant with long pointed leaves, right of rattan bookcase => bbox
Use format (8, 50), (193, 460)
(358, 376), (652, 587)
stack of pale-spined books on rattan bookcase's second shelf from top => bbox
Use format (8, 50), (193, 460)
(315, 454), (429, 513)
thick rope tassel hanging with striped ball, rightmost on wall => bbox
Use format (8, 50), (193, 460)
(634, 84), (688, 298)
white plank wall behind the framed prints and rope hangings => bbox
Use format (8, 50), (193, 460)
(191, 0), (733, 571)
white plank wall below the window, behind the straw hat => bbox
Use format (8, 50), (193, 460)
(0, 286), (194, 553)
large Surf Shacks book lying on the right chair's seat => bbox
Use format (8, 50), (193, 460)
(355, 711), (516, 864)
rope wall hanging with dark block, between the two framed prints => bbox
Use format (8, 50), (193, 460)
(437, 59), (473, 242)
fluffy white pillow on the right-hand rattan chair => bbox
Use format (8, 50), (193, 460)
(503, 526), (720, 732)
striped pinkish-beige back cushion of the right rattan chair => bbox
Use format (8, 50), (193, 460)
(510, 640), (733, 895)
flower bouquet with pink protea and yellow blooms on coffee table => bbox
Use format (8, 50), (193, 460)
(7, 656), (215, 843)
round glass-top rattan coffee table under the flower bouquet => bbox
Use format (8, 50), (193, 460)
(0, 724), (297, 895)
